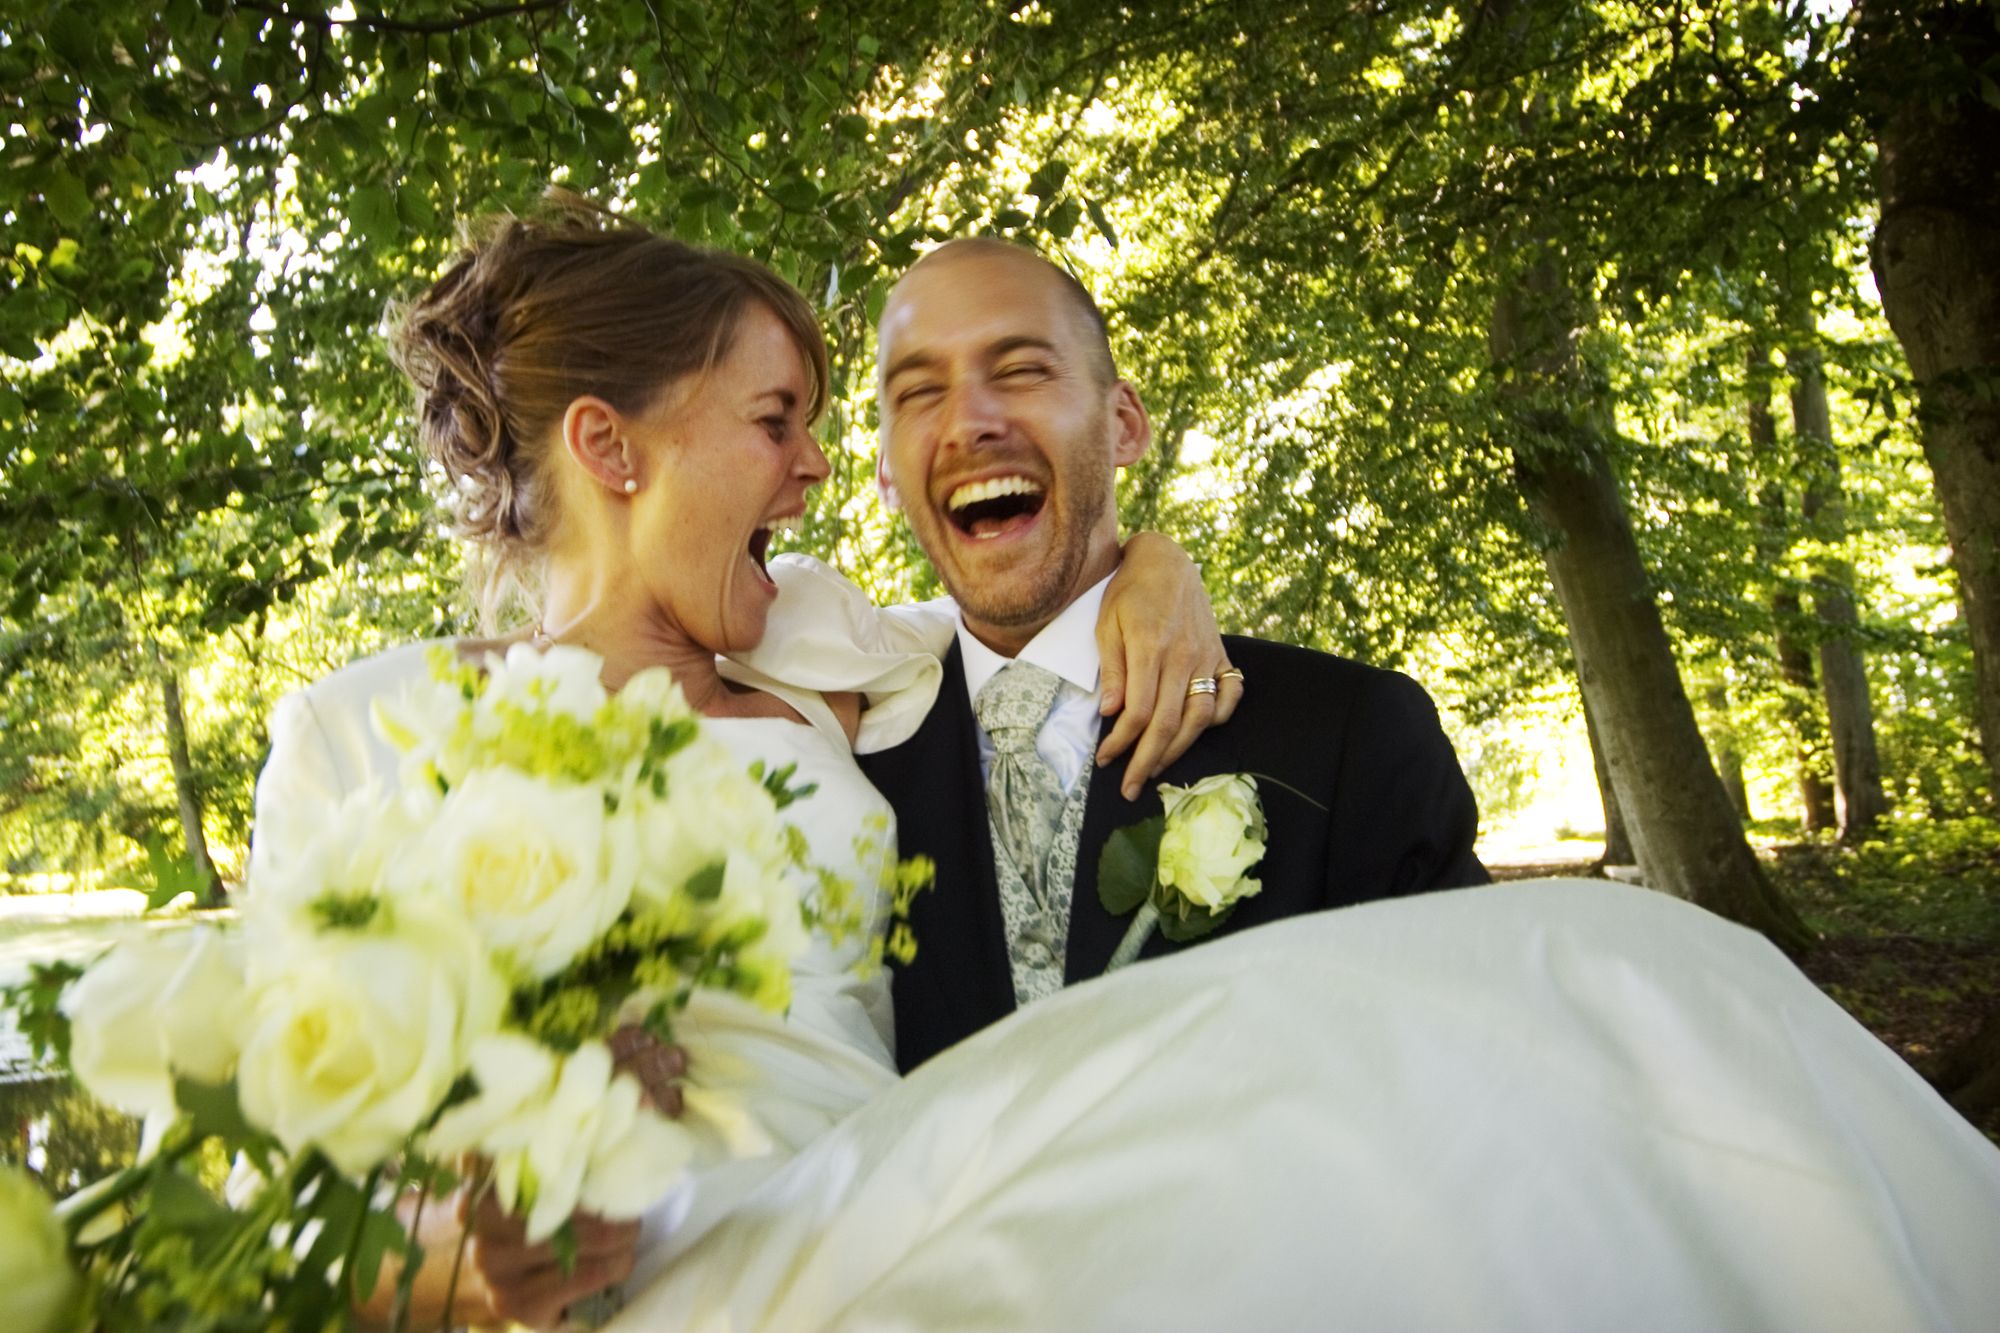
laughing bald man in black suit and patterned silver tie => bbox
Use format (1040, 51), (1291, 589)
(862, 238), (1486, 1069)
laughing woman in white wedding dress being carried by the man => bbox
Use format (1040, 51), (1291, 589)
(266, 200), (2000, 1329)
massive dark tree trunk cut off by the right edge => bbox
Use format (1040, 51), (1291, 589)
(1856, 0), (2000, 803)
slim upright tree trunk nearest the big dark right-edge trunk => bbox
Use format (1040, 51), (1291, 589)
(1786, 332), (1888, 843)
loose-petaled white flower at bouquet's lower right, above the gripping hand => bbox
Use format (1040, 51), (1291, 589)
(426, 1033), (694, 1241)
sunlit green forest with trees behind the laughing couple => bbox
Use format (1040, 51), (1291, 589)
(0, 0), (2000, 1117)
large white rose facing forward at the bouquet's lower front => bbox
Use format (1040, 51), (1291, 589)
(236, 899), (506, 1175)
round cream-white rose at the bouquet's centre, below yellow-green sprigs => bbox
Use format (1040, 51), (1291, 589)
(392, 769), (640, 977)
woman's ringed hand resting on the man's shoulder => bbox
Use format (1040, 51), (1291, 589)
(1098, 532), (1244, 801)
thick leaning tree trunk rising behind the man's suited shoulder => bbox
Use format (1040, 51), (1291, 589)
(1490, 262), (1808, 949)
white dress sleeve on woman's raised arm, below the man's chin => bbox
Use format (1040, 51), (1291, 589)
(720, 554), (958, 753)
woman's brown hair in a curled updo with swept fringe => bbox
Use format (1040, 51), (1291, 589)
(390, 188), (828, 614)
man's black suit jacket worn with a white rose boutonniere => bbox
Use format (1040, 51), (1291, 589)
(860, 636), (1486, 1069)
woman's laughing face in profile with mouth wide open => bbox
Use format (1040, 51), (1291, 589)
(630, 302), (826, 652)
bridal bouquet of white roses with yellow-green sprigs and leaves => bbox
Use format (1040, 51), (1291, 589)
(0, 646), (860, 1329)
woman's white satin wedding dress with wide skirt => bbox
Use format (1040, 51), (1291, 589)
(252, 556), (2000, 1333)
